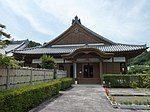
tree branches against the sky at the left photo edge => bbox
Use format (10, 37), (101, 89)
(0, 24), (10, 47)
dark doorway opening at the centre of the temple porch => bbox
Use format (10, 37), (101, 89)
(83, 63), (93, 78)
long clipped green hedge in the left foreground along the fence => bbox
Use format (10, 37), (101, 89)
(0, 80), (61, 112)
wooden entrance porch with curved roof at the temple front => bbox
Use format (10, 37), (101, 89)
(62, 48), (113, 84)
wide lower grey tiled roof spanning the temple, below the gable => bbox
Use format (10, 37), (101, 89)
(14, 44), (147, 54)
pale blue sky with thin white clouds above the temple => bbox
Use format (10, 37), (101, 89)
(0, 0), (150, 49)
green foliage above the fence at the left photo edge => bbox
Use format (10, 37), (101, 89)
(0, 55), (22, 68)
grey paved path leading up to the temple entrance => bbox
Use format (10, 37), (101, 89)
(36, 85), (148, 112)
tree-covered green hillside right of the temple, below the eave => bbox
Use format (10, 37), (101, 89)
(128, 52), (150, 65)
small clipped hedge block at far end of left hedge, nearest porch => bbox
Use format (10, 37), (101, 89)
(60, 78), (73, 90)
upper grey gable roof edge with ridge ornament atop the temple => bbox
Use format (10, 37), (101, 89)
(43, 16), (116, 47)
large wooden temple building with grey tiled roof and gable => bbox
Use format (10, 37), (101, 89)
(14, 16), (148, 84)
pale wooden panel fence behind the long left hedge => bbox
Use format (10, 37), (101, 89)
(0, 68), (67, 91)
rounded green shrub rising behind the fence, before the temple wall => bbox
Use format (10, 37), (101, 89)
(40, 55), (55, 69)
